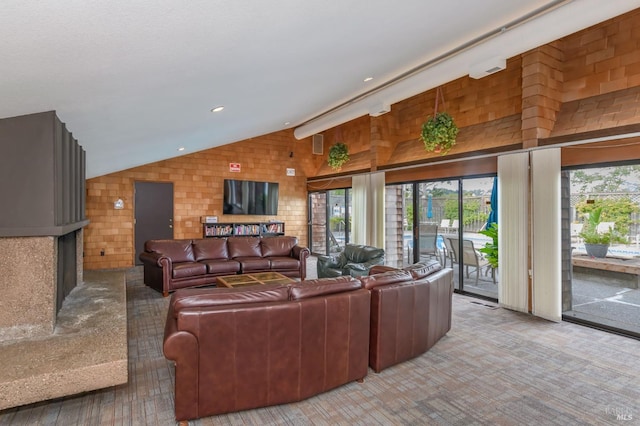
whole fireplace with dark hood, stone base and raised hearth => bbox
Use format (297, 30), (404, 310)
(0, 111), (128, 410)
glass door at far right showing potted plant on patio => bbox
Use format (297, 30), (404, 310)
(562, 164), (640, 336)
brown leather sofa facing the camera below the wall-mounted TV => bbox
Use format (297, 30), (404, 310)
(140, 236), (309, 297)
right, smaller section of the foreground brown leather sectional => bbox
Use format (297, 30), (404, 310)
(359, 261), (453, 373)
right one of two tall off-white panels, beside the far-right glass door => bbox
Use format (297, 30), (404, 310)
(531, 148), (562, 321)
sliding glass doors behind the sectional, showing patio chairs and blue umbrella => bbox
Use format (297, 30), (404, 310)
(385, 177), (498, 300)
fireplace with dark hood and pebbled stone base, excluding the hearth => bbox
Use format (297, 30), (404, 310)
(0, 111), (88, 342)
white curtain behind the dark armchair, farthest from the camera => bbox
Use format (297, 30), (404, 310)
(351, 172), (385, 248)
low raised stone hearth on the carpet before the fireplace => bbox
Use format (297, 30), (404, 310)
(0, 270), (128, 410)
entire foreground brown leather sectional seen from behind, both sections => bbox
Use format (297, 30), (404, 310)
(164, 262), (453, 421)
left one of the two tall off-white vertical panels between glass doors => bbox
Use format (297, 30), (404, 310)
(498, 152), (529, 312)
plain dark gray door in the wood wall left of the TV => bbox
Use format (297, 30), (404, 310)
(134, 182), (173, 265)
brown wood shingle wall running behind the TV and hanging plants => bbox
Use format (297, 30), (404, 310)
(85, 9), (640, 269)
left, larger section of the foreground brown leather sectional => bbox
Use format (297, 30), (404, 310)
(163, 277), (371, 421)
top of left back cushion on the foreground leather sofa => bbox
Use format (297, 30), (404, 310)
(170, 284), (289, 318)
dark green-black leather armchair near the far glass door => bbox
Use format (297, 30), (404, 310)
(318, 244), (384, 278)
